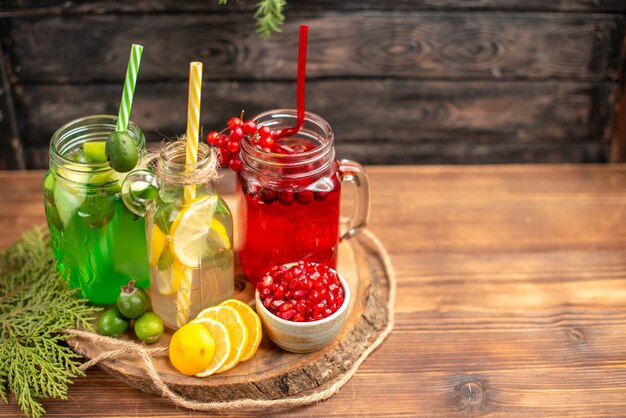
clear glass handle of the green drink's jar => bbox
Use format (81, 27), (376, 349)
(121, 168), (159, 218)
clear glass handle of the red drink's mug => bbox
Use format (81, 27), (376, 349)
(338, 160), (370, 241)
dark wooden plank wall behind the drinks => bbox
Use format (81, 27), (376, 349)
(0, 0), (626, 168)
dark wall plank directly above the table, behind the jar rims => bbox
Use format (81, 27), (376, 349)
(15, 80), (613, 168)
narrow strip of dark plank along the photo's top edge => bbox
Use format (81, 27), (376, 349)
(0, 0), (626, 17)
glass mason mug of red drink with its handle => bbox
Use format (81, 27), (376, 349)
(237, 109), (370, 283)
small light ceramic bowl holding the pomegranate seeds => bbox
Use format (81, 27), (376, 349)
(254, 270), (350, 353)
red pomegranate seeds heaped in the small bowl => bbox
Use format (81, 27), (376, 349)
(257, 261), (345, 322)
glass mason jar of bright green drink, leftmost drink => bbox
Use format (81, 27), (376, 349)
(43, 115), (150, 304)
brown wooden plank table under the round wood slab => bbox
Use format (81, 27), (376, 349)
(0, 165), (626, 417)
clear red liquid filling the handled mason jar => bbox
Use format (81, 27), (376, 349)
(237, 142), (341, 283)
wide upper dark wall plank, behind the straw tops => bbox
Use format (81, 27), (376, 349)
(4, 12), (624, 84)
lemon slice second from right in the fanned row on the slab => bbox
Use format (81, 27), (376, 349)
(196, 306), (248, 373)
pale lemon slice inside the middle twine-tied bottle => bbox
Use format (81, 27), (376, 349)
(170, 195), (223, 268)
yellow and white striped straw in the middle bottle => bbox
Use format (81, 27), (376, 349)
(176, 62), (202, 327)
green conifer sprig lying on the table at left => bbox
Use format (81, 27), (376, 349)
(0, 227), (99, 418)
